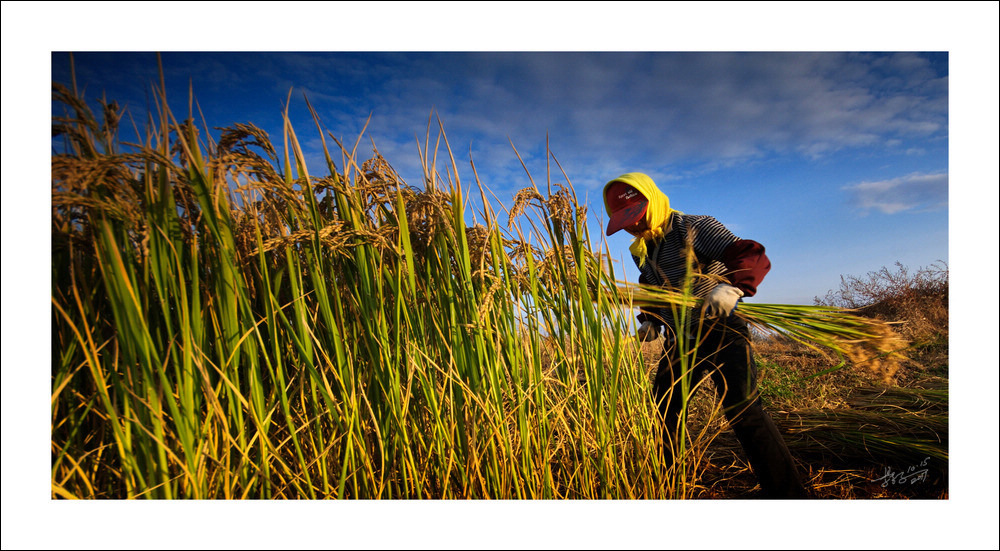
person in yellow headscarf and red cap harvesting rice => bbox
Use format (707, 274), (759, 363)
(604, 172), (808, 498)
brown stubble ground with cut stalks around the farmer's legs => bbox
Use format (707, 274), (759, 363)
(643, 341), (948, 499)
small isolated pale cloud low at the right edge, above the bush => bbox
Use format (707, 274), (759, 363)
(843, 173), (948, 214)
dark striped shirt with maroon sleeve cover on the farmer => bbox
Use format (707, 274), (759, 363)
(632, 211), (771, 325)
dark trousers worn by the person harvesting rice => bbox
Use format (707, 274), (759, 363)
(653, 316), (808, 498)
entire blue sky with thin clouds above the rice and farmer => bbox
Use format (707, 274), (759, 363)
(52, 52), (949, 304)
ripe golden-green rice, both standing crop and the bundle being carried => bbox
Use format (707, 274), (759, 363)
(51, 63), (944, 499)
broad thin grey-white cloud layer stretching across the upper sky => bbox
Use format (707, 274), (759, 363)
(256, 52), (947, 180)
